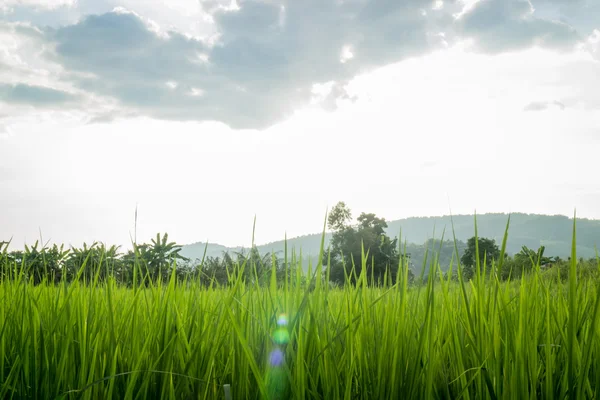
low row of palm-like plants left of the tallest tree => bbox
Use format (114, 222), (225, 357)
(0, 233), (292, 286)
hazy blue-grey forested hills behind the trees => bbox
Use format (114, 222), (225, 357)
(181, 213), (600, 272)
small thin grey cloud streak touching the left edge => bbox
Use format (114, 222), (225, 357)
(0, 83), (77, 106)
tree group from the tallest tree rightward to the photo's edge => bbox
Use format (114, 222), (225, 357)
(323, 202), (600, 284)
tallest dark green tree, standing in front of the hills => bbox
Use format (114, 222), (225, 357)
(323, 202), (399, 284)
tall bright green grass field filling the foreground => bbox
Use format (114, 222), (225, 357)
(0, 217), (600, 399)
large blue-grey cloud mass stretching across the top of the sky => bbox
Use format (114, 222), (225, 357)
(0, 0), (592, 129)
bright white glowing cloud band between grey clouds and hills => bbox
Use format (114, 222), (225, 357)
(0, 48), (600, 245)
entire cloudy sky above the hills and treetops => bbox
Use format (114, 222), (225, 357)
(0, 0), (600, 248)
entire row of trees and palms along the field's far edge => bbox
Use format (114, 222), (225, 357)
(0, 202), (598, 286)
